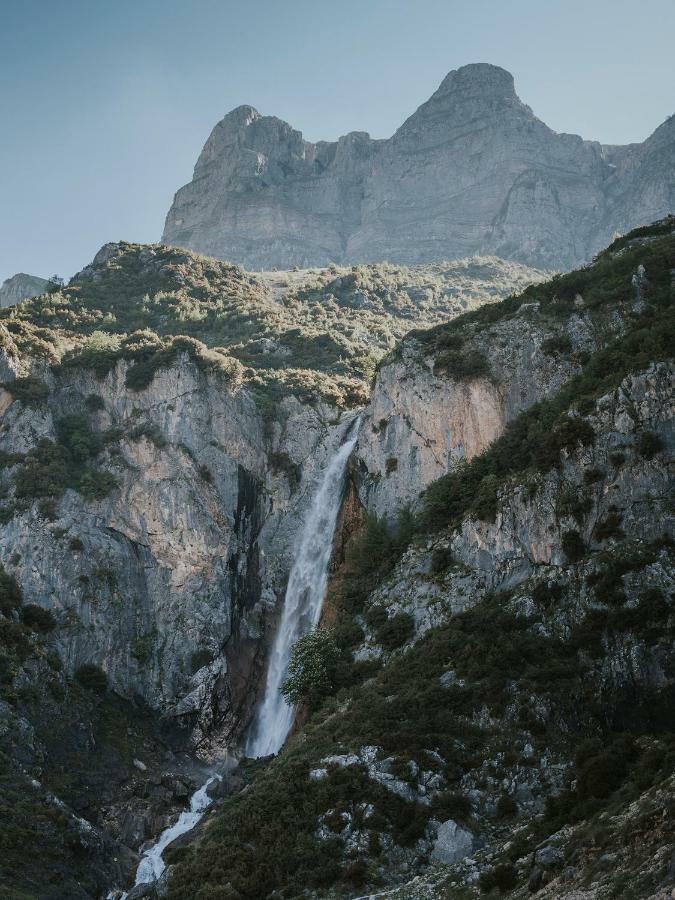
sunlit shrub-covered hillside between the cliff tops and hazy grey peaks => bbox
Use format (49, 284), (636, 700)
(0, 243), (544, 406)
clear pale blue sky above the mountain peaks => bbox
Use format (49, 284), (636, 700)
(0, 0), (675, 281)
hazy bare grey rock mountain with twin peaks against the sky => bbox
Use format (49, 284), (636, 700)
(162, 64), (675, 269)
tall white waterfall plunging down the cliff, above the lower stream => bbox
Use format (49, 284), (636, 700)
(246, 419), (359, 757)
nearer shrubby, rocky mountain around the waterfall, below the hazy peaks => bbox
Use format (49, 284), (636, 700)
(0, 218), (675, 900)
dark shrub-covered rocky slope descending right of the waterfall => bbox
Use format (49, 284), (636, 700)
(170, 222), (675, 900)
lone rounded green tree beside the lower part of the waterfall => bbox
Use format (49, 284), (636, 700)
(281, 628), (340, 707)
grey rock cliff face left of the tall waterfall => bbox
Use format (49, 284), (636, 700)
(0, 348), (356, 744)
